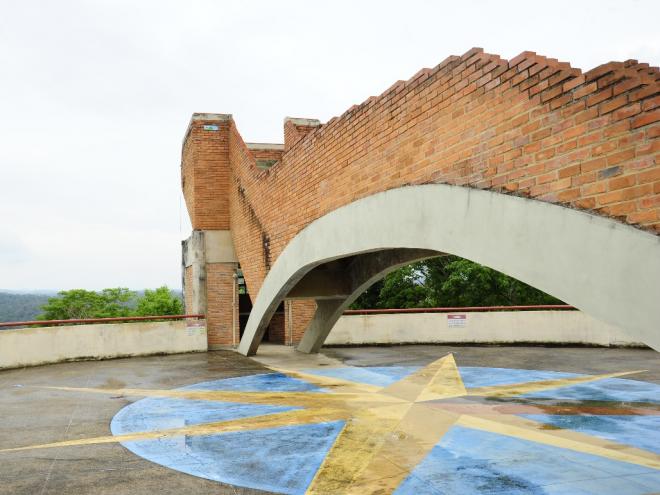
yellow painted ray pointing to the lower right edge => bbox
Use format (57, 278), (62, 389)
(456, 414), (660, 469)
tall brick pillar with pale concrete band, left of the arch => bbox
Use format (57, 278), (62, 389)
(181, 113), (239, 349)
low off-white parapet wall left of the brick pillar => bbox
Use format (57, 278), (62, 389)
(0, 320), (207, 369)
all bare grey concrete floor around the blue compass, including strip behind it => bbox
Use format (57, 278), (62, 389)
(0, 346), (660, 495)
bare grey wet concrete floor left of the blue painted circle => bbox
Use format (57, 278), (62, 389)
(0, 351), (274, 495)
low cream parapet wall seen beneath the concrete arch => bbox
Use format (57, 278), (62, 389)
(325, 311), (644, 347)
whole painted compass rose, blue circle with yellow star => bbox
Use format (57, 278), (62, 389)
(5, 354), (660, 494)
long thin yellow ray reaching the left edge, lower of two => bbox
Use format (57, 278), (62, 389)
(0, 409), (348, 452)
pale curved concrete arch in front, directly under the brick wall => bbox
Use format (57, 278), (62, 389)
(239, 184), (660, 355)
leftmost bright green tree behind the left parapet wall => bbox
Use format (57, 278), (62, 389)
(37, 287), (135, 320)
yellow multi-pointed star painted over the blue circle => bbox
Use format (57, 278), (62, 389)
(0, 354), (660, 494)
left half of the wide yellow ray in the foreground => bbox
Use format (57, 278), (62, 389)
(306, 404), (412, 495)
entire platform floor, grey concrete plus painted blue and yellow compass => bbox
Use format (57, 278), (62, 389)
(0, 345), (660, 495)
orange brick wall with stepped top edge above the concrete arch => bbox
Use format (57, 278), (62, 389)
(184, 48), (660, 322)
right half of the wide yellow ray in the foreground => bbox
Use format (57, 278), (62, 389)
(345, 403), (459, 494)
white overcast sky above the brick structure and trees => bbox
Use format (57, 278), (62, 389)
(0, 0), (660, 289)
